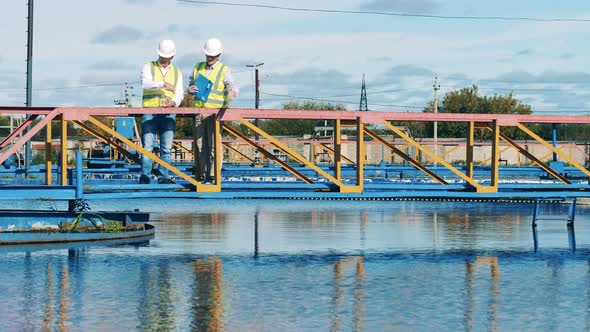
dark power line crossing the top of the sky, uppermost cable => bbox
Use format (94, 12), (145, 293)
(176, 0), (590, 22)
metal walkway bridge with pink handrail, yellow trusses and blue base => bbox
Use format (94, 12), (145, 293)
(0, 107), (590, 200)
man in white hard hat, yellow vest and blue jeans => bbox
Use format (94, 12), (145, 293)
(139, 39), (184, 184)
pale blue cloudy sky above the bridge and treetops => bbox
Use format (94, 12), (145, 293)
(0, 0), (590, 115)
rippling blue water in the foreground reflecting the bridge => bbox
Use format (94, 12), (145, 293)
(0, 204), (590, 331)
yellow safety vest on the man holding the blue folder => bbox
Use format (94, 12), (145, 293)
(193, 62), (229, 108)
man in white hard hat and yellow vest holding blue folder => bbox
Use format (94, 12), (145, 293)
(188, 38), (240, 182)
